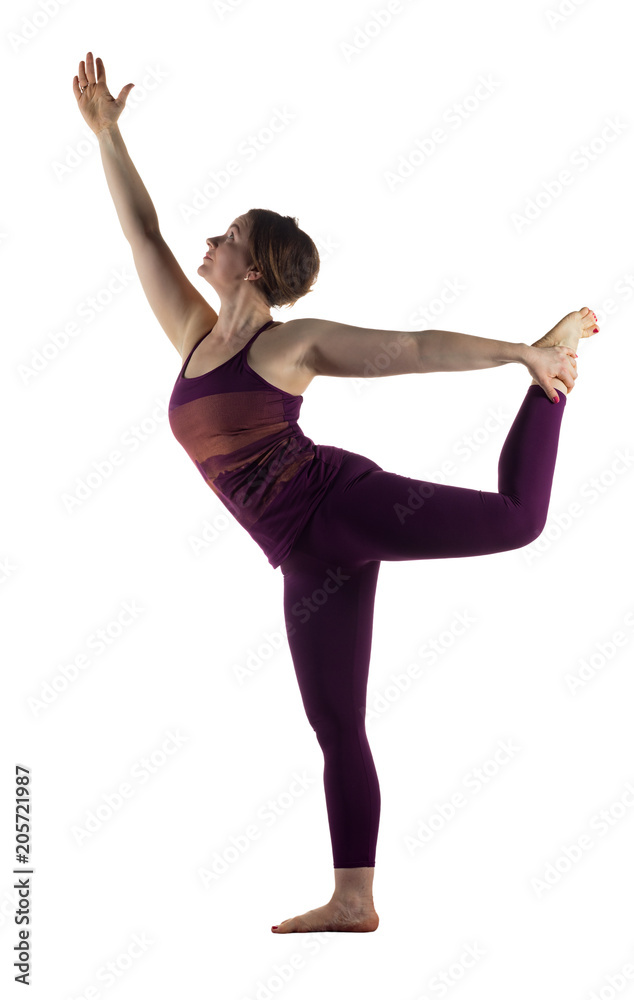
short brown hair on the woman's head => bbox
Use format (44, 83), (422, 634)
(245, 208), (319, 308)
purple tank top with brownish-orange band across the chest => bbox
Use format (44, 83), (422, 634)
(168, 320), (345, 569)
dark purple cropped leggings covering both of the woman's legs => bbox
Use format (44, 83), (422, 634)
(281, 385), (567, 868)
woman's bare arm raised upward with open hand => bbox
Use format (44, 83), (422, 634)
(73, 52), (218, 356)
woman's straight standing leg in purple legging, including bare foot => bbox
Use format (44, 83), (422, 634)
(270, 540), (381, 933)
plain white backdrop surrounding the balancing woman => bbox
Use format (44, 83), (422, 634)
(0, 0), (634, 1000)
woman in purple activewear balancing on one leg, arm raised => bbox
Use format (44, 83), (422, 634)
(73, 52), (598, 933)
